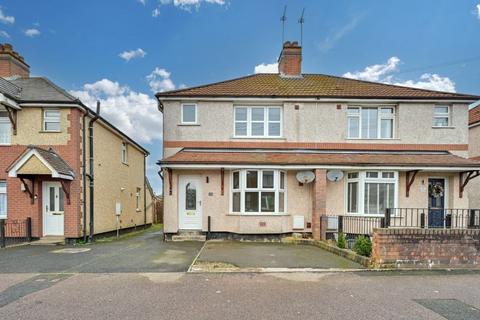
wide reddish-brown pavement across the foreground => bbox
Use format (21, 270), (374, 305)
(0, 272), (480, 320)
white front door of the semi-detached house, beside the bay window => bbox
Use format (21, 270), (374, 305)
(178, 176), (202, 230)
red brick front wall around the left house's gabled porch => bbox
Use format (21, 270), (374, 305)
(0, 109), (82, 238)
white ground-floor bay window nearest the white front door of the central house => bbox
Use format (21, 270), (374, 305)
(230, 169), (287, 214)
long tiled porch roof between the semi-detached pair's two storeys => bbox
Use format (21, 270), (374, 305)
(158, 149), (480, 171)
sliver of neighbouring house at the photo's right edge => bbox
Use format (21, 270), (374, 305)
(468, 101), (480, 208)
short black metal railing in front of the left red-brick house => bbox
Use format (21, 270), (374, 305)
(0, 217), (32, 248)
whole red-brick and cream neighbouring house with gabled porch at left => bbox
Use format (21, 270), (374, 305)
(0, 44), (153, 240)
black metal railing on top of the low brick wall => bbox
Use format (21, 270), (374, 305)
(384, 208), (480, 229)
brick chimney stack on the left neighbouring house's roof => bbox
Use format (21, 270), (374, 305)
(0, 43), (30, 78)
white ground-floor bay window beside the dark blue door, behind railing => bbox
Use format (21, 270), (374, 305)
(346, 171), (398, 215)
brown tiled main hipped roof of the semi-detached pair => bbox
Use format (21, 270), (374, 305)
(156, 73), (480, 101)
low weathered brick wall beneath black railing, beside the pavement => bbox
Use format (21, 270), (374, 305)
(372, 229), (480, 268)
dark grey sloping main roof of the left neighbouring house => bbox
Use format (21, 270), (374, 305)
(10, 77), (78, 102)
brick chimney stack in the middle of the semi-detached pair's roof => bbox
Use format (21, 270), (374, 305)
(278, 41), (302, 78)
